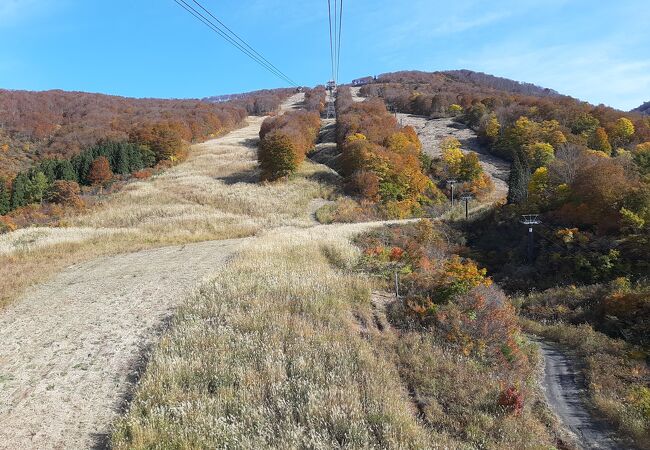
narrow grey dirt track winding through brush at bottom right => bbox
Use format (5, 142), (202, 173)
(539, 342), (625, 450)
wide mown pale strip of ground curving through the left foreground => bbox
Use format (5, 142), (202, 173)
(0, 240), (246, 449)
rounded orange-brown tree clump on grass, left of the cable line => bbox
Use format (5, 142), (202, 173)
(258, 111), (320, 181)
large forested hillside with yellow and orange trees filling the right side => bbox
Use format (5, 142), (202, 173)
(354, 71), (650, 448)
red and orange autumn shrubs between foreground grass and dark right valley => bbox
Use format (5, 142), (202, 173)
(356, 220), (534, 415)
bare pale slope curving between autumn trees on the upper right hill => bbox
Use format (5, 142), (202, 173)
(397, 114), (510, 201)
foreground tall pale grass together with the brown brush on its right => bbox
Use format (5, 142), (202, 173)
(113, 225), (553, 449)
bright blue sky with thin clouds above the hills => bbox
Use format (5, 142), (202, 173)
(0, 0), (650, 110)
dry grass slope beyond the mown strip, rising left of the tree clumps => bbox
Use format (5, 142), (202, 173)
(0, 117), (340, 308)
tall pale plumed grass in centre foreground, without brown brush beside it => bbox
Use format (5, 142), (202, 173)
(114, 228), (449, 449)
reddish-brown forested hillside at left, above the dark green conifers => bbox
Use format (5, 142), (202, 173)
(0, 89), (291, 175)
